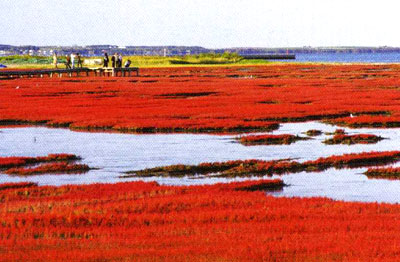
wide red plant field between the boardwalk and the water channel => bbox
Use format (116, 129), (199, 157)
(0, 64), (400, 132)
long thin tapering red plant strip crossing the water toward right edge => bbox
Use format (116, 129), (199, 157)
(123, 151), (400, 177)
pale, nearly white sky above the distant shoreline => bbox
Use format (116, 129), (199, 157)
(0, 0), (400, 48)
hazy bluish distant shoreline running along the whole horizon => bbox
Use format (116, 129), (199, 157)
(0, 44), (400, 56)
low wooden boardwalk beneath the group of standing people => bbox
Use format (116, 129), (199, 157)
(0, 67), (139, 79)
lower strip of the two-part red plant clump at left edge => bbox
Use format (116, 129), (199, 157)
(4, 163), (90, 176)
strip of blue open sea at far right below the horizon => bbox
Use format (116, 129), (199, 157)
(282, 52), (400, 63)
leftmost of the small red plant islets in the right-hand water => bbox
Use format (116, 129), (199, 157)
(237, 134), (307, 146)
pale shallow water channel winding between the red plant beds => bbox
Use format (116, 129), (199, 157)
(0, 122), (400, 203)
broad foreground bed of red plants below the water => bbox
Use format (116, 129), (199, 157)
(0, 181), (400, 262)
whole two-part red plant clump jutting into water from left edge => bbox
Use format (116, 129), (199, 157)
(0, 154), (90, 176)
